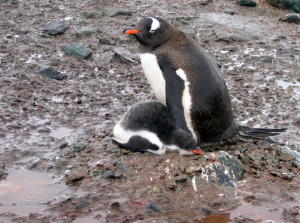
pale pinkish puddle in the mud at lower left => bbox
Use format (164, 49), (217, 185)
(0, 170), (67, 218)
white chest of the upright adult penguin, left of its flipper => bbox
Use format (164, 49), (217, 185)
(139, 53), (166, 105)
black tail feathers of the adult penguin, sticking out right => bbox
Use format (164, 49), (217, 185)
(236, 126), (287, 141)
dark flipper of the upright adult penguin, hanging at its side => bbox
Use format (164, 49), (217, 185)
(158, 55), (189, 132)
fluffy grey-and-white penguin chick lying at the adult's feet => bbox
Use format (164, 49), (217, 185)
(113, 101), (196, 155)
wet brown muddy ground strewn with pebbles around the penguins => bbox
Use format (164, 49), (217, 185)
(0, 0), (300, 223)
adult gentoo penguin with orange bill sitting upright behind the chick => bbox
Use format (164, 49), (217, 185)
(124, 17), (286, 146)
